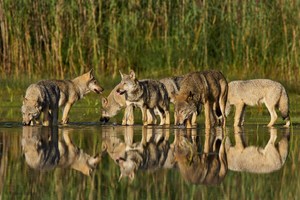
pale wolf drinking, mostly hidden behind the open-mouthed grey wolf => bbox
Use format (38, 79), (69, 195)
(100, 76), (183, 125)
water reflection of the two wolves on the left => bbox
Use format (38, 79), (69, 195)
(21, 126), (101, 175)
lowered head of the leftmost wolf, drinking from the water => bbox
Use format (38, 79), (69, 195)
(21, 98), (42, 125)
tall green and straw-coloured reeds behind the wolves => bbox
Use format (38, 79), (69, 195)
(0, 0), (300, 82)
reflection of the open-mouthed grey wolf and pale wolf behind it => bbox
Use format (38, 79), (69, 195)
(102, 126), (175, 181)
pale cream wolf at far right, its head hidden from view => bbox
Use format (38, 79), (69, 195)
(226, 79), (291, 127)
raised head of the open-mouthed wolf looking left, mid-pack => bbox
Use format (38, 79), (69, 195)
(116, 70), (138, 95)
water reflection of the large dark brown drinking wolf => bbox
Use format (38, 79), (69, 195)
(174, 127), (228, 185)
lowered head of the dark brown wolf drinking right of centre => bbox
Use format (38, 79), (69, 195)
(175, 93), (197, 126)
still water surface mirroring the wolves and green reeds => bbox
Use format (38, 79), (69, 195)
(0, 107), (300, 199)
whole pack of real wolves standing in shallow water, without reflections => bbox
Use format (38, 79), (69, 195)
(21, 70), (291, 128)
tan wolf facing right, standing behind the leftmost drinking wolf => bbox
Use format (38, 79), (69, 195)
(54, 70), (104, 124)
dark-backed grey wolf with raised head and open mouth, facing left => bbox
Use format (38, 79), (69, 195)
(117, 70), (170, 125)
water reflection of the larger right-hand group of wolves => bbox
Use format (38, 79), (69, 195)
(102, 126), (289, 185)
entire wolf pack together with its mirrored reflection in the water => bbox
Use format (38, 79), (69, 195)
(21, 70), (291, 180)
